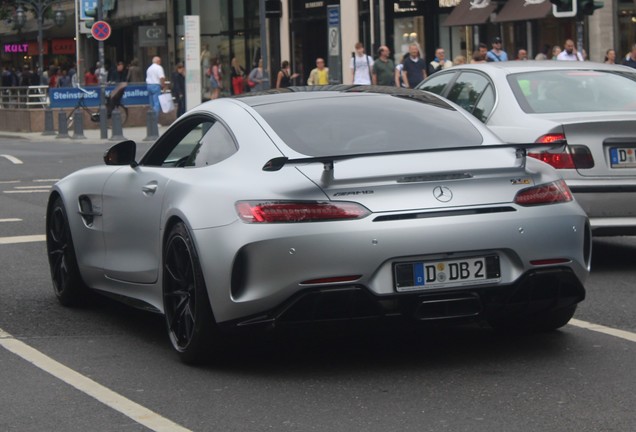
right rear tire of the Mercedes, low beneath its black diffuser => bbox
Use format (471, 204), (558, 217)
(489, 305), (576, 333)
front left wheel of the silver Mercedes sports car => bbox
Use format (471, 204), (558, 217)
(46, 196), (89, 306)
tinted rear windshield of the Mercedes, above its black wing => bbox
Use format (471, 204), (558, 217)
(253, 95), (482, 156)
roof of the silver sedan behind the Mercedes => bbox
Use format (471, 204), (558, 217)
(444, 60), (636, 76)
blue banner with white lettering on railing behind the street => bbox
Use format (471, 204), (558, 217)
(49, 84), (148, 108)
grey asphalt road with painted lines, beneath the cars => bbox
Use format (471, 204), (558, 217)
(0, 139), (636, 432)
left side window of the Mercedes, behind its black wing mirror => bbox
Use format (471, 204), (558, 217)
(140, 116), (238, 168)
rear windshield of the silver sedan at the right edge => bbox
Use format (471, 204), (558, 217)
(508, 70), (636, 113)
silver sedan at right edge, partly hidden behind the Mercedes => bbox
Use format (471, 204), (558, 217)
(418, 61), (636, 235)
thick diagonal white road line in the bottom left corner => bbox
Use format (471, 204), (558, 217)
(0, 328), (189, 432)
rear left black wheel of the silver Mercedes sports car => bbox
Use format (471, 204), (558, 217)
(162, 222), (216, 364)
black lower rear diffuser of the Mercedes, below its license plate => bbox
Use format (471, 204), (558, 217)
(223, 267), (585, 328)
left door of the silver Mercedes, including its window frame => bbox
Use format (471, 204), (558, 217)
(103, 115), (224, 283)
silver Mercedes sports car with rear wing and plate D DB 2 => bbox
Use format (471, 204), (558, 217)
(46, 86), (591, 362)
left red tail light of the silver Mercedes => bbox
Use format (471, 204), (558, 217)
(236, 201), (371, 223)
